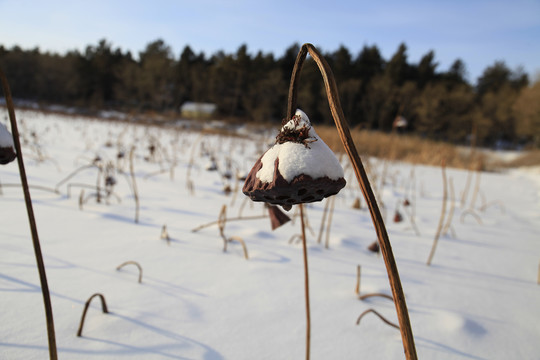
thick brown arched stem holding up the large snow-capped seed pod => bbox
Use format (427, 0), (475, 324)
(287, 44), (417, 360)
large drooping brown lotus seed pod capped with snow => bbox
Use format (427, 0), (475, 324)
(242, 110), (346, 210)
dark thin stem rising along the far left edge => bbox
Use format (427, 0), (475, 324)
(0, 69), (58, 360)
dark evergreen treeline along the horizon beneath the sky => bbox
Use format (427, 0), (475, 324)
(0, 40), (540, 146)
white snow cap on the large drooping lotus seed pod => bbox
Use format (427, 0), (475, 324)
(256, 110), (343, 183)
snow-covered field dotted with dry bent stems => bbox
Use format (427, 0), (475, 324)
(0, 109), (540, 360)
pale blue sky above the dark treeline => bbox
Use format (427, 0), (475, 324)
(0, 0), (540, 83)
